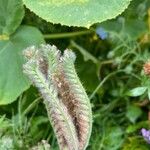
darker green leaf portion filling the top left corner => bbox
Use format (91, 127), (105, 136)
(0, 0), (24, 37)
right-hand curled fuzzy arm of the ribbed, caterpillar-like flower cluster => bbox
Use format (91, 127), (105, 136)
(62, 50), (92, 150)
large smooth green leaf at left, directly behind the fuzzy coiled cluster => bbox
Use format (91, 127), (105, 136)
(0, 26), (44, 105)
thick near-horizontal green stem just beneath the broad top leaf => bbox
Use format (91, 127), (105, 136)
(44, 30), (94, 39)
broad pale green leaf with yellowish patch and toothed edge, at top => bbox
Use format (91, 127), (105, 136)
(23, 0), (131, 27)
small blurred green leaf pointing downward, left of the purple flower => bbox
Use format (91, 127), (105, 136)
(126, 105), (142, 123)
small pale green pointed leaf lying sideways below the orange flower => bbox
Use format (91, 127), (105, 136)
(127, 87), (147, 97)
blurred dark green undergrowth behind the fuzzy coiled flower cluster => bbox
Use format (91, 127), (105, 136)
(0, 0), (150, 150)
